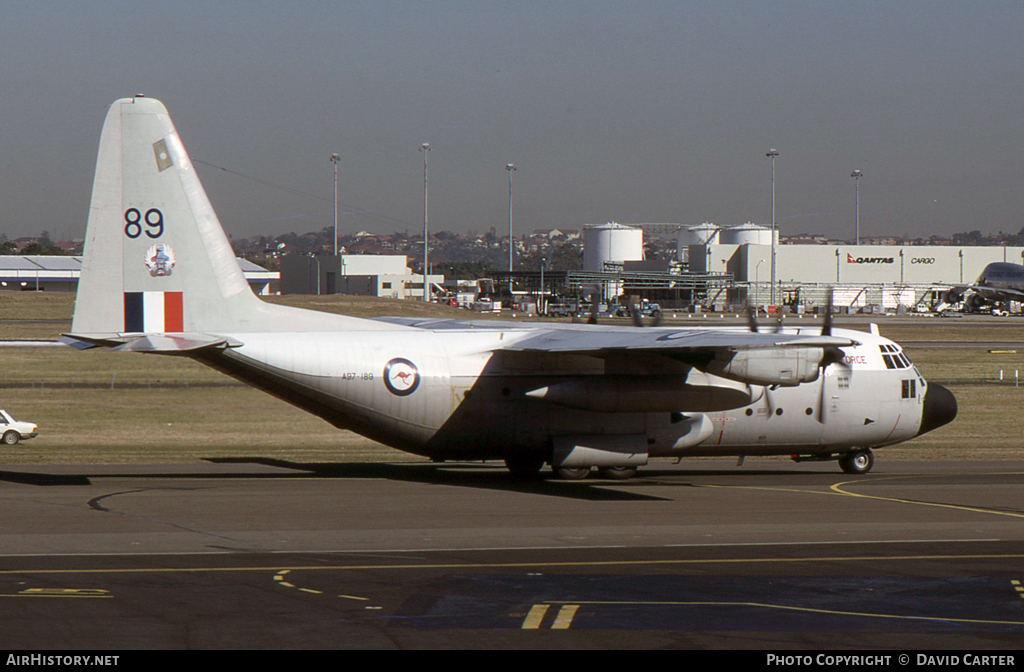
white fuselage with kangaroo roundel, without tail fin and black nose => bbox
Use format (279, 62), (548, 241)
(200, 328), (942, 459)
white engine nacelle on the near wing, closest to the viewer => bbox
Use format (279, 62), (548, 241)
(706, 347), (825, 385)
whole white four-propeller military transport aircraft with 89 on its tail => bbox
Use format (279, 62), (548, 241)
(63, 96), (956, 478)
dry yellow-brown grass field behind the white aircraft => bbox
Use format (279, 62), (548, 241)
(0, 292), (1024, 464)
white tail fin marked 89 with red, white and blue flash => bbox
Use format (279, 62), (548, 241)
(72, 96), (379, 334)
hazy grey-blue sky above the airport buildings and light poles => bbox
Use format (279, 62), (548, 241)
(0, 0), (1024, 238)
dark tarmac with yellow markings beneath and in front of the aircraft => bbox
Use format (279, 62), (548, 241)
(0, 458), (1024, 650)
